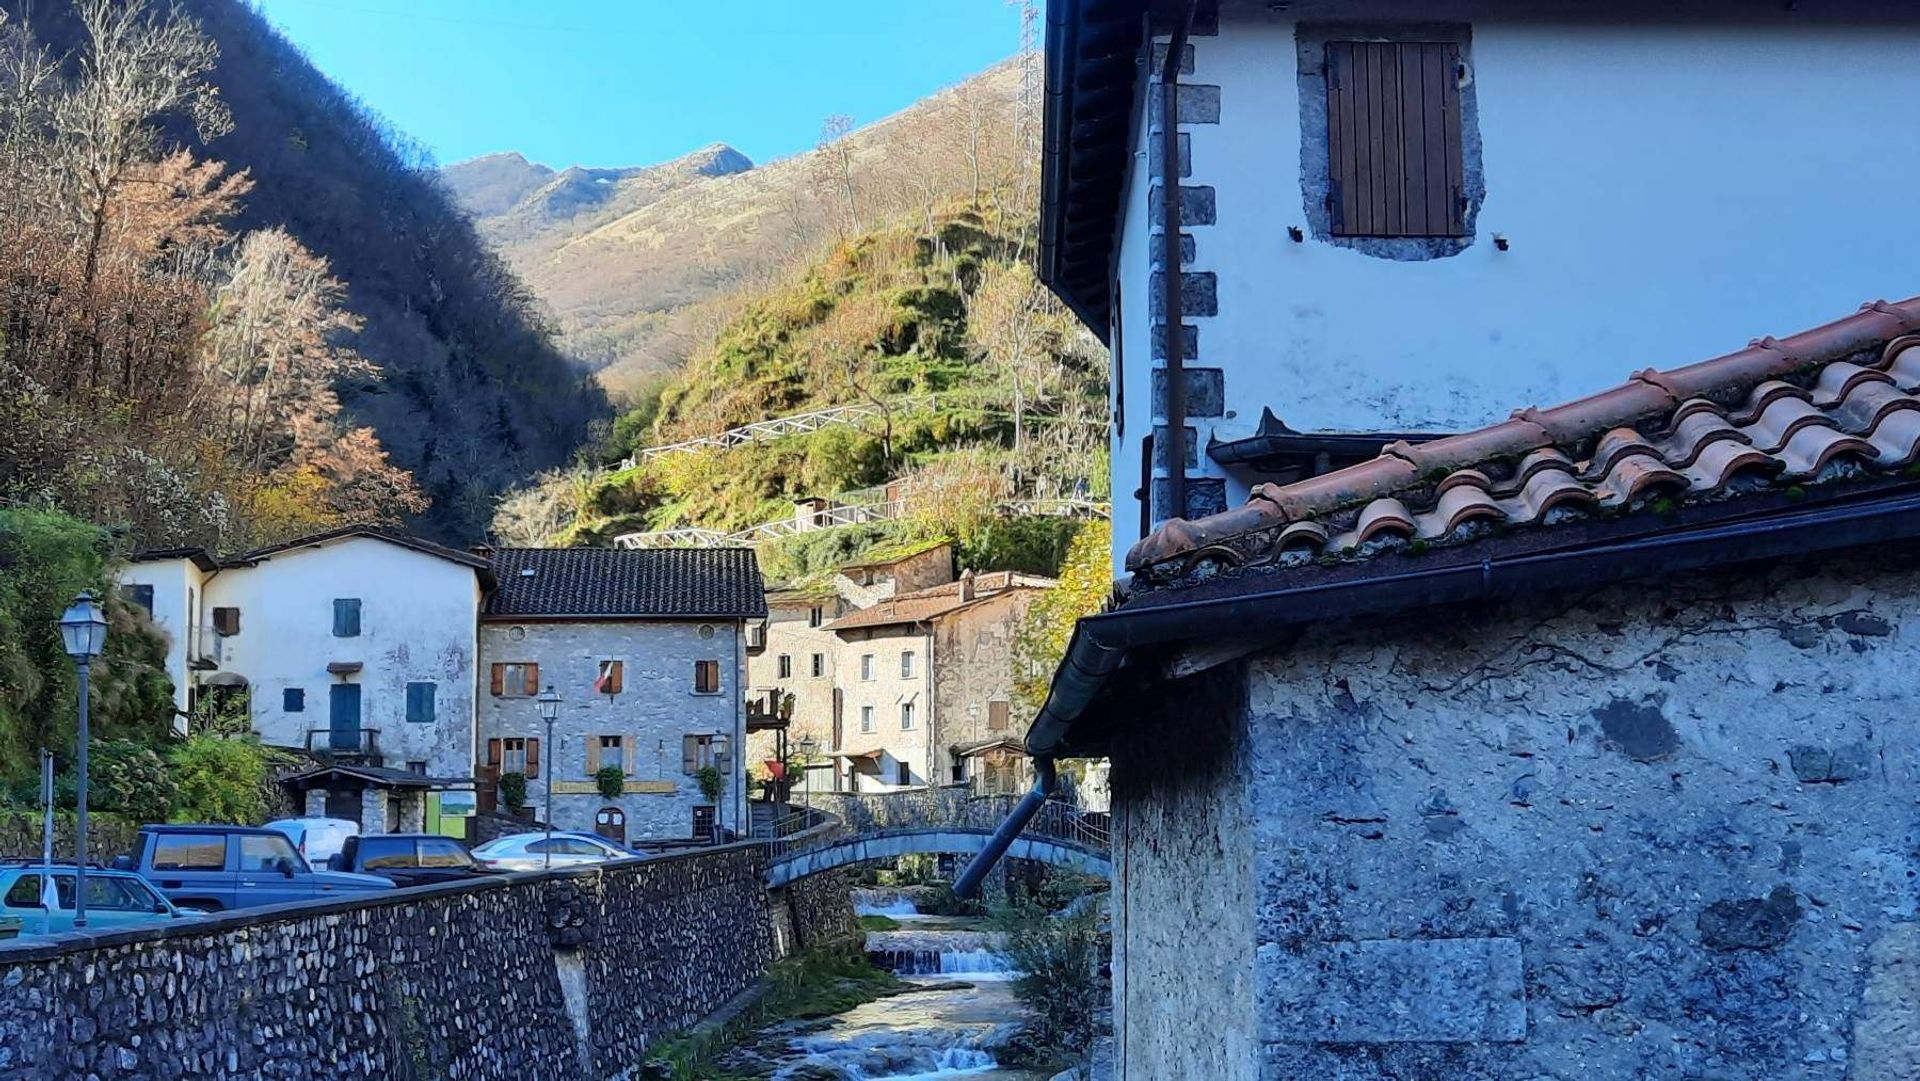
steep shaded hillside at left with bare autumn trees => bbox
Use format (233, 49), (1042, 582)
(0, 0), (605, 547)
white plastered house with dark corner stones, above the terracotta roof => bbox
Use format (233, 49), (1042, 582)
(1041, 0), (1920, 568)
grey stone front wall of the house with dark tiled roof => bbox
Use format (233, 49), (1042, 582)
(480, 618), (745, 843)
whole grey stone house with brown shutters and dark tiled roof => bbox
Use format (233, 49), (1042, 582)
(478, 549), (768, 843)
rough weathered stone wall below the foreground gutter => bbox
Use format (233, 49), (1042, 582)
(1114, 545), (1920, 1081)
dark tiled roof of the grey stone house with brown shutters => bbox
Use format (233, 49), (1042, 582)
(484, 547), (766, 618)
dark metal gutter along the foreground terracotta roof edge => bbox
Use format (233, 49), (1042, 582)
(1027, 484), (1920, 758)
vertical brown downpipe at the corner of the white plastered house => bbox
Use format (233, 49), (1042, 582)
(1146, 0), (1200, 518)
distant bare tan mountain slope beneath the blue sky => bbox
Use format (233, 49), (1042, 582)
(445, 61), (1039, 394)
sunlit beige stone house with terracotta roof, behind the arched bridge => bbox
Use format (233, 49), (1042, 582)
(828, 572), (1054, 791)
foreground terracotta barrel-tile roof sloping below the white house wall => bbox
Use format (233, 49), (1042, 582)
(1127, 298), (1920, 588)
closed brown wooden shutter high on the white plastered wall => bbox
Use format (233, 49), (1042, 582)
(1327, 42), (1467, 236)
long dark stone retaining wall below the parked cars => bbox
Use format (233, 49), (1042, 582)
(0, 845), (845, 1081)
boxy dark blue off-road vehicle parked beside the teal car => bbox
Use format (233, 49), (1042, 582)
(113, 826), (394, 912)
